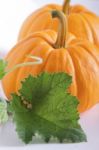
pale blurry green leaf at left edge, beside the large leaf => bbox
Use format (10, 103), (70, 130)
(0, 98), (8, 124)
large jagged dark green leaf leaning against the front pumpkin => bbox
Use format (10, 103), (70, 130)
(10, 73), (86, 143)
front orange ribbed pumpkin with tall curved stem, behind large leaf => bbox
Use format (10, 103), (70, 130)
(3, 11), (99, 112)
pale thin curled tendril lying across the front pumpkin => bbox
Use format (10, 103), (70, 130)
(5, 55), (42, 76)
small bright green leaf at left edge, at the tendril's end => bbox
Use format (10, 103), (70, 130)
(0, 59), (7, 80)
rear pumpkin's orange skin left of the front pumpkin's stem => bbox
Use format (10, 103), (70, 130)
(18, 5), (61, 40)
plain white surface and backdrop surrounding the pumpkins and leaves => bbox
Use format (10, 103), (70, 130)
(0, 0), (99, 150)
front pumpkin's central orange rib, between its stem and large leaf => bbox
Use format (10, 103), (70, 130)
(44, 48), (77, 96)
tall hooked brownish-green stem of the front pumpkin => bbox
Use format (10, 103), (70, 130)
(52, 10), (68, 48)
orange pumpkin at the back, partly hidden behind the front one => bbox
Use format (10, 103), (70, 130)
(18, 0), (99, 46)
